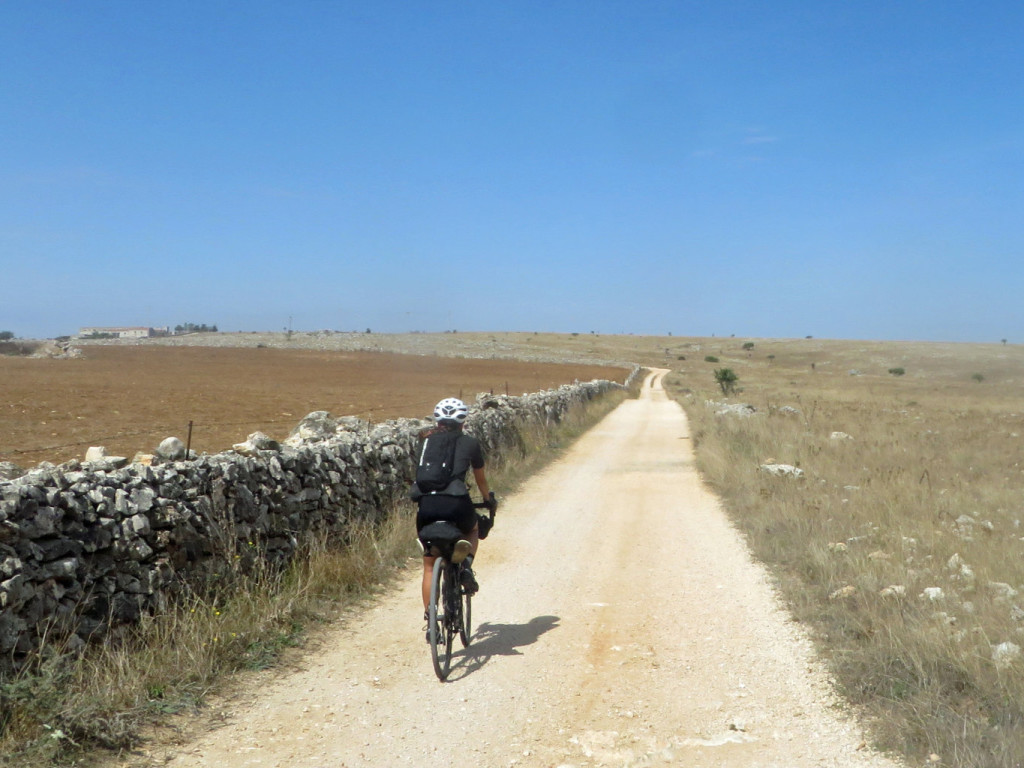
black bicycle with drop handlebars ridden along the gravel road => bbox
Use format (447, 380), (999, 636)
(419, 493), (498, 682)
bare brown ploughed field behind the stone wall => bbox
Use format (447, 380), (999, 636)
(0, 346), (628, 468)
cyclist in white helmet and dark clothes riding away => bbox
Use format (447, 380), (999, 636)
(412, 397), (490, 610)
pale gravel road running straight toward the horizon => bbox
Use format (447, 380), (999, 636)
(157, 372), (894, 768)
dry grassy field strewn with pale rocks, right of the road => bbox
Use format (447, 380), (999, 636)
(666, 339), (1024, 768)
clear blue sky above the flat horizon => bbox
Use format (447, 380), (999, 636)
(0, 0), (1024, 342)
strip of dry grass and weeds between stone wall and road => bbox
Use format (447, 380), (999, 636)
(0, 392), (628, 768)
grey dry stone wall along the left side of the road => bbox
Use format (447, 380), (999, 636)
(0, 372), (636, 677)
